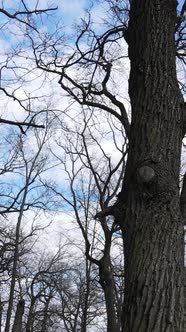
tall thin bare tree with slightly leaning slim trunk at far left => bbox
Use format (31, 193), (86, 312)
(0, 118), (56, 331)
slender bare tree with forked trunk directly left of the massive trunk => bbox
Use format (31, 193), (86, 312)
(46, 110), (127, 331)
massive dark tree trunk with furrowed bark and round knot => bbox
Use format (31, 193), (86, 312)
(121, 0), (184, 332)
